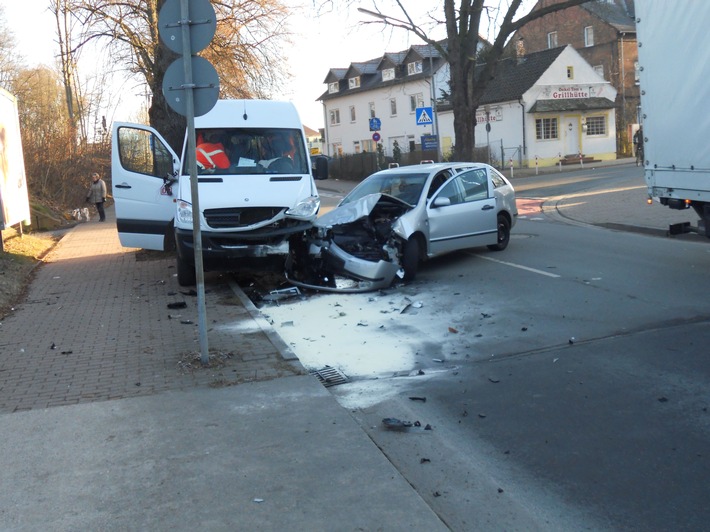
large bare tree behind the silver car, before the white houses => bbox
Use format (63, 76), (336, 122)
(358, 0), (590, 161)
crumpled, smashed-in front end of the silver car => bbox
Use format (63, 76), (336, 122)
(286, 194), (413, 293)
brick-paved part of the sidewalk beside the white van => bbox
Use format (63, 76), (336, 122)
(0, 208), (305, 412)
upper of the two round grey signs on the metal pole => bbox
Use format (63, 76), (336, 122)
(158, 0), (217, 54)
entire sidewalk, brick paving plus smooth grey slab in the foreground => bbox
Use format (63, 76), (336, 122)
(0, 209), (446, 531)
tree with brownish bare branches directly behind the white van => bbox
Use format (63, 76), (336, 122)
(71, 0), (288, 149)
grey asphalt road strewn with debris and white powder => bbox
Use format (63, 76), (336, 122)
(250, 168), (710, 530)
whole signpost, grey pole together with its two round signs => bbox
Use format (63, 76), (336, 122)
(158, 0), (219, 366)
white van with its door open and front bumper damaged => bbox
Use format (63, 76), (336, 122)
(111, 100), (328, 286)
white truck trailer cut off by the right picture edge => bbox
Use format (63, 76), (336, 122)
(635, 0), (710, 237)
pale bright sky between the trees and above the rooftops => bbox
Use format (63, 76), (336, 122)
(0, 0), (536, 129)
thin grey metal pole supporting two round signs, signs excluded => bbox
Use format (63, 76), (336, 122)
(180, 0), (210, 366)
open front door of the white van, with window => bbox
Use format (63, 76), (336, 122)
(111, 122), (180, 251)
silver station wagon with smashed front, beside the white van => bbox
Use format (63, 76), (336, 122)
(286, 163), (518, 292)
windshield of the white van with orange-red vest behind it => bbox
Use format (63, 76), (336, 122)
(183, 128), (310, 175)
